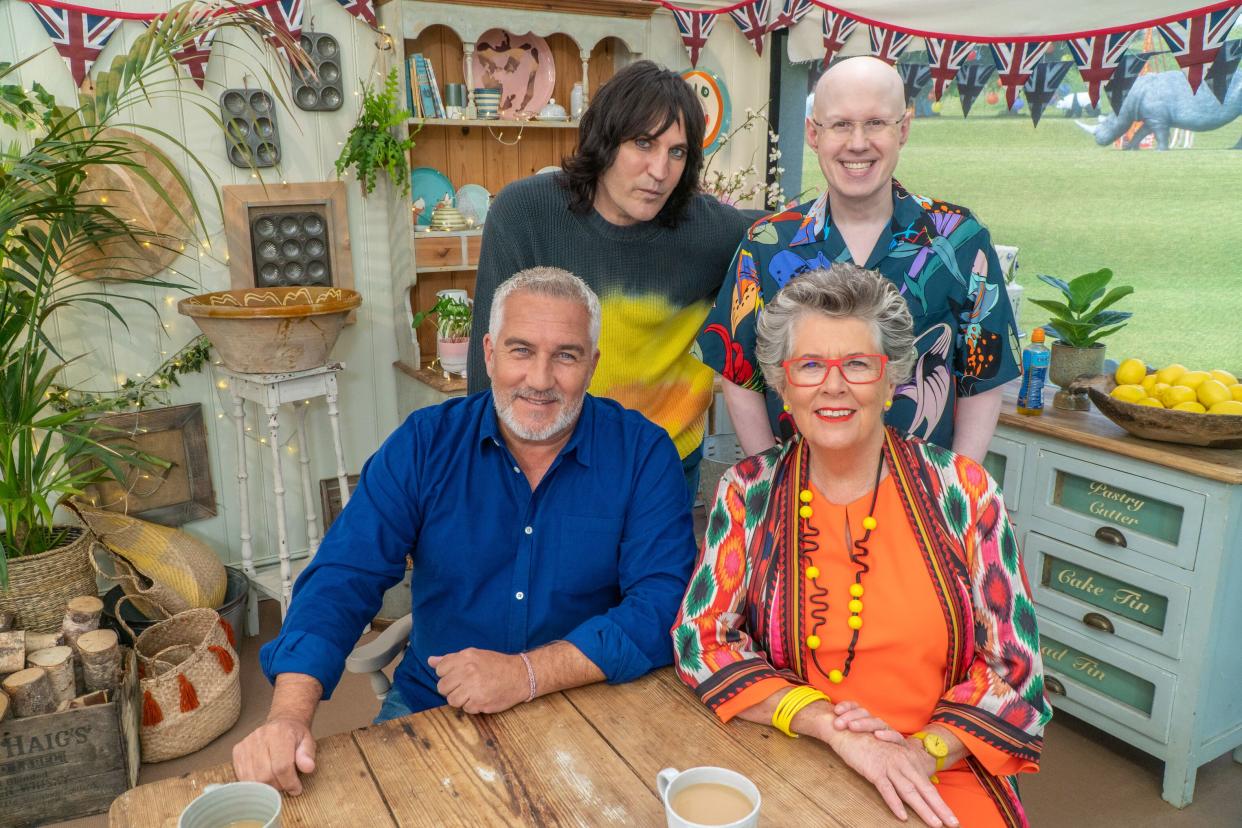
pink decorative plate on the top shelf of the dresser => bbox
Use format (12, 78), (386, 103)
(473, 29), (556, 119)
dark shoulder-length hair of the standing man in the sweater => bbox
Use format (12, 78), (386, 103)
(561, 61), (704, 227)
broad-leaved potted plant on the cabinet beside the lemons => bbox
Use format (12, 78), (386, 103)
(1031, 267), (1134, 411)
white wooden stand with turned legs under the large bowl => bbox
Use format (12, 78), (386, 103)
(224, 362), (349, 636)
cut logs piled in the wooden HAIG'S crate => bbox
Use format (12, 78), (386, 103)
(0, 596), (122, 721)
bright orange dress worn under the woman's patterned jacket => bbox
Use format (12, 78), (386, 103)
(718, 477), (1022, 828)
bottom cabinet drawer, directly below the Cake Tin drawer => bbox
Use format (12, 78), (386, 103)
(1036, 612), (1177, 744)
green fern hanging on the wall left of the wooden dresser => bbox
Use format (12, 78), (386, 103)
(337, 70), (414, 195)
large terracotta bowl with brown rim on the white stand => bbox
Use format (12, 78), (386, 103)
(176, 287), (363, 374)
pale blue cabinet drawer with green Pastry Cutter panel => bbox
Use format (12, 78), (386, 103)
(1032, 449), (1205, 570)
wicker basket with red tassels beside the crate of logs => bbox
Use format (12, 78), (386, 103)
(134, 610), (241, 762)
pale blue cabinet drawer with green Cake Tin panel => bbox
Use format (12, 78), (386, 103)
(1025, 531), (1190, 658)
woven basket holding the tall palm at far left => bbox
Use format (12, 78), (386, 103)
(0, 526), (99, 633)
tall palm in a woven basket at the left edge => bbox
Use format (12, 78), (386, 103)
(0, 2), (298, 632)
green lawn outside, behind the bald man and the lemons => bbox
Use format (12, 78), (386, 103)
(802, 116), (1242, 372)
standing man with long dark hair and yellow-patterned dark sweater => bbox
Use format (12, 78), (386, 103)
(468, 61), (749, 497)
